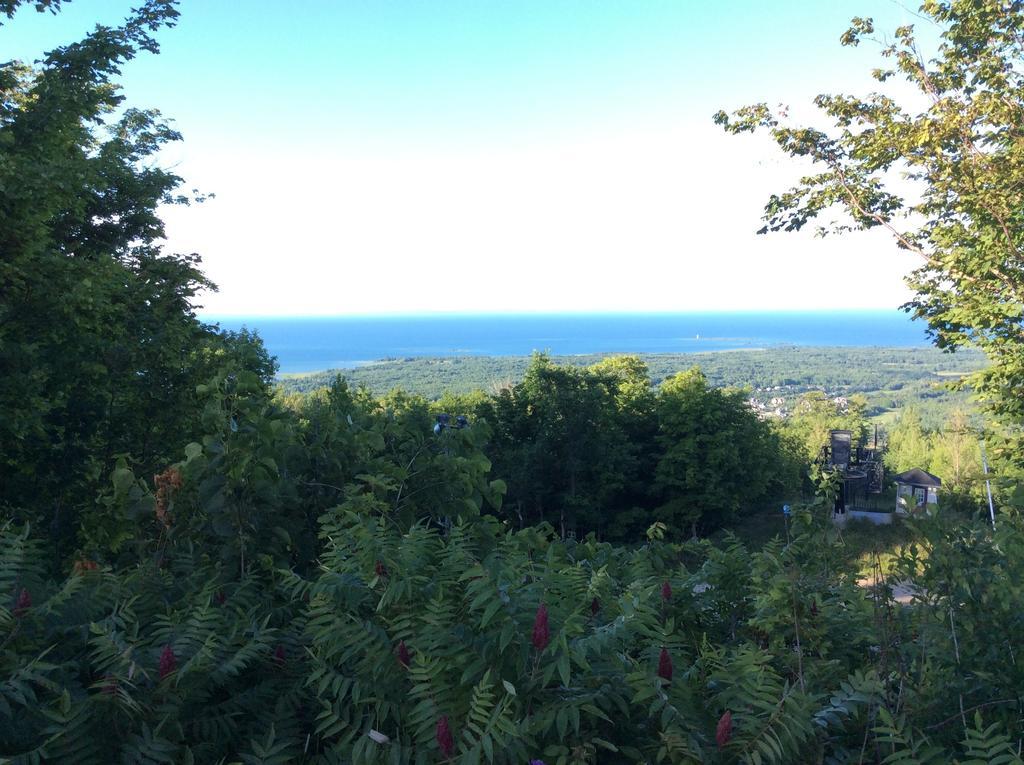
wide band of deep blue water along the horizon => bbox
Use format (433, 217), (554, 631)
(203, 310), (927, 373)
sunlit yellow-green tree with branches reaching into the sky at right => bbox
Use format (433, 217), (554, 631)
(715, 0), (1024, 485)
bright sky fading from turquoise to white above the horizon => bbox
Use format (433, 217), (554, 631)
(0, 0), (919, 315)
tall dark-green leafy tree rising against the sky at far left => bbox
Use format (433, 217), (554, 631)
(0, 0), (272, 553)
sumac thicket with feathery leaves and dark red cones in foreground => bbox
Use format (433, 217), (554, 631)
(0, 493), (1024, 765)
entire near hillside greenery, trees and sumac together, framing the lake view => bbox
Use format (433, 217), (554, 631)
(0, 0), (1024, 765)
